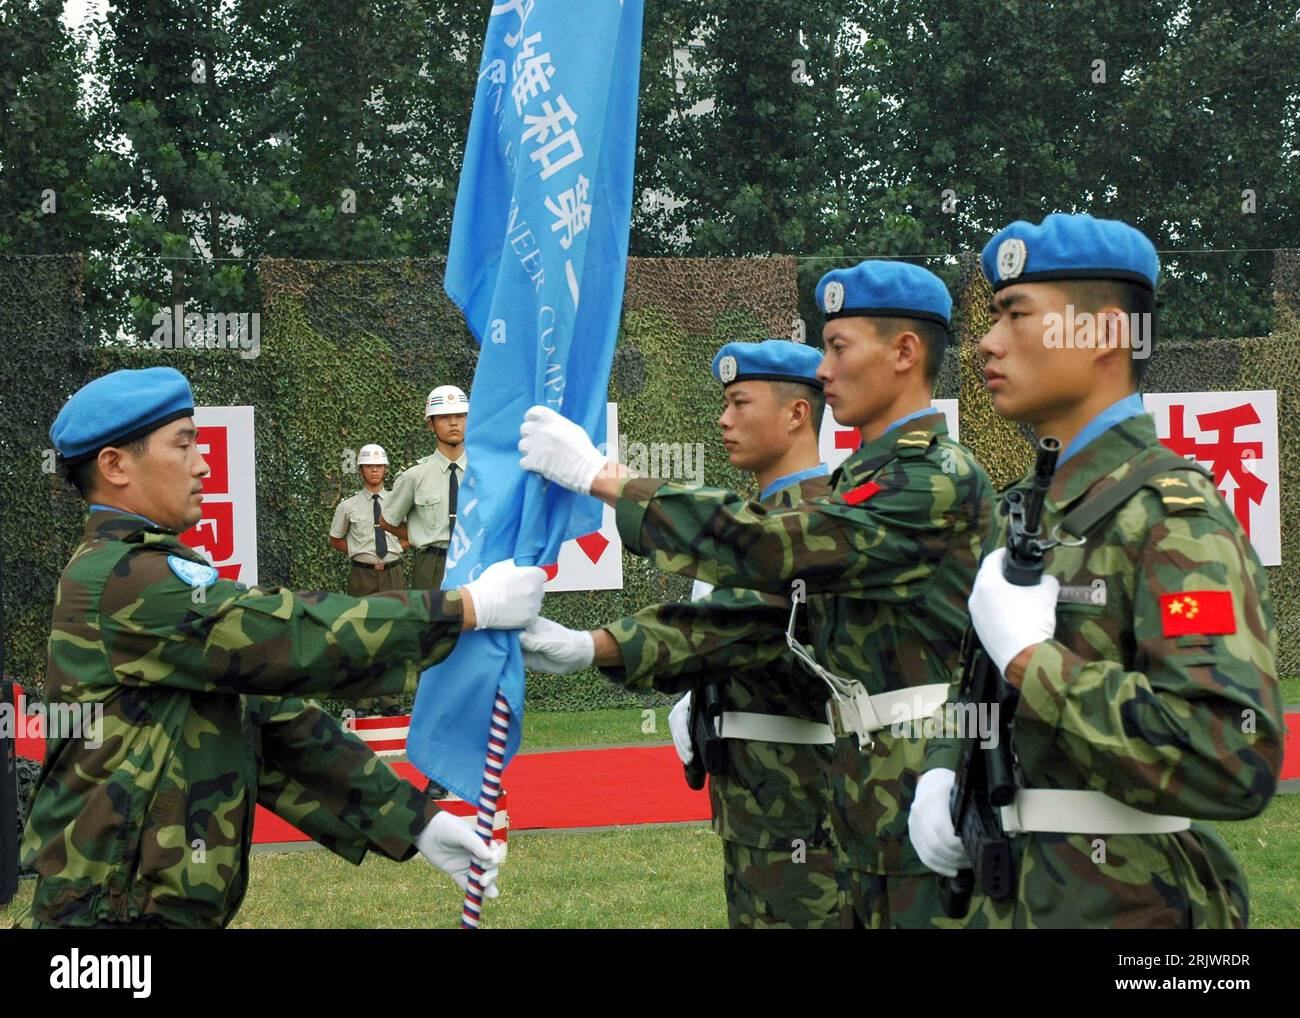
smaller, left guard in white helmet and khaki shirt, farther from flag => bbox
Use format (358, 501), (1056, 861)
(329, 445), (407, 716)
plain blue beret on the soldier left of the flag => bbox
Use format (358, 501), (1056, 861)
(49, 368), (194, 465)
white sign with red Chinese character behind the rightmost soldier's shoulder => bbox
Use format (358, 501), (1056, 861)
(1143, 389), (1282, 566)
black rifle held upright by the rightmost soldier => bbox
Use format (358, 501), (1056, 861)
(939, 438), (1061, 919)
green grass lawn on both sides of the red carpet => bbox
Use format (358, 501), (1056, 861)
(0, 712), (1300, 928)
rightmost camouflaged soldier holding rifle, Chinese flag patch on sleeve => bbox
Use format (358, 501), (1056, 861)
(913, 215), (1282, 928)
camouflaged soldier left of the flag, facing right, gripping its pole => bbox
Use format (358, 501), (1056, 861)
(20, 368), (545, 927)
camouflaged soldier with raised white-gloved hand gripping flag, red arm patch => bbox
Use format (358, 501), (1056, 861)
(520, 261), (992, 927)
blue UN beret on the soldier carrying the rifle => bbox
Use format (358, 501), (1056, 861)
(980, 212), (1160, 291)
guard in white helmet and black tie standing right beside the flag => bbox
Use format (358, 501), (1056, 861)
(381, 385), (469, 590)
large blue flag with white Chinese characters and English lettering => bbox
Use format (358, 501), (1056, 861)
(408, 0), (644, 802)
